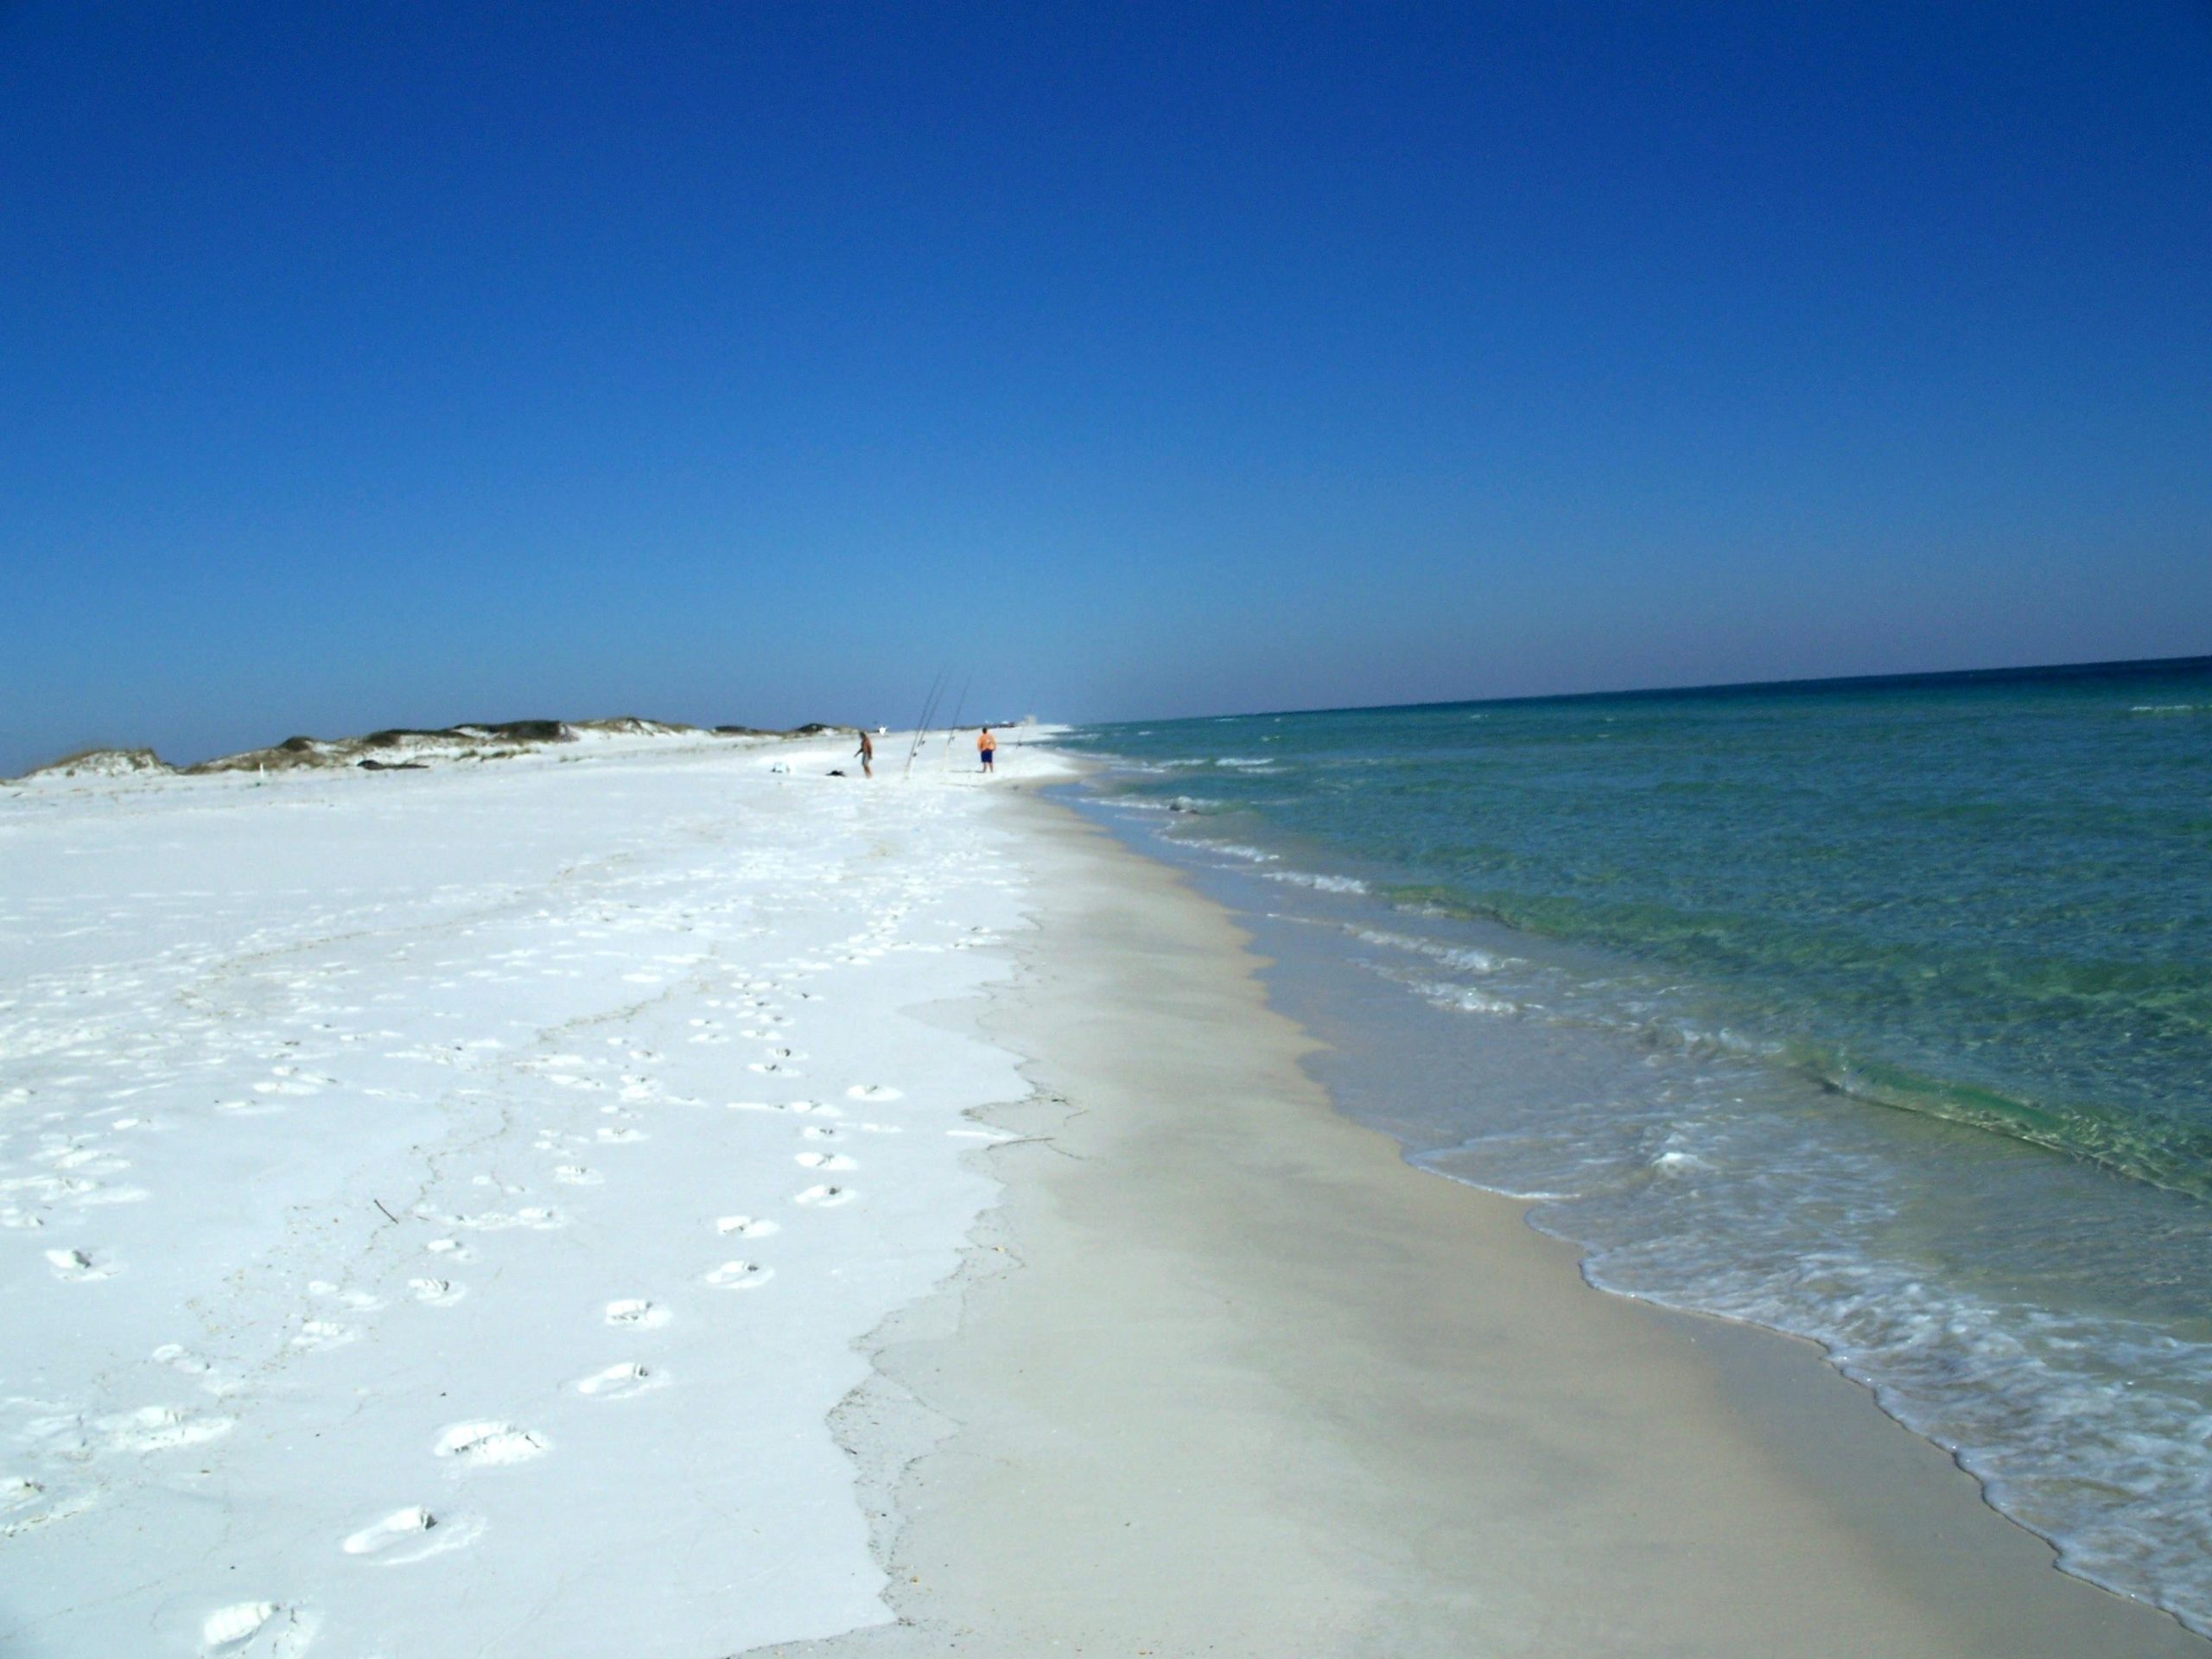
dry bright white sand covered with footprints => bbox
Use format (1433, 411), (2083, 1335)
(0, 739), (1065, 1659)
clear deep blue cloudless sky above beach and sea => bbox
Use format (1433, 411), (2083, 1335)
(0, 0), (2212, 772)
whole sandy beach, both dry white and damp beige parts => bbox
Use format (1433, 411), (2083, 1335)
(0, 736), (2208, 1659)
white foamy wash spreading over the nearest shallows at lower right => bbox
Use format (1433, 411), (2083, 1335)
(1414, 1008), (2212, 1630)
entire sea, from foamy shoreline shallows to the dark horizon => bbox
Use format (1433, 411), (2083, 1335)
(1052, 659), (2212, 1632)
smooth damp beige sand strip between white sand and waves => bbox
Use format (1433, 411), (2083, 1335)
(770, 801), (2212, 1659)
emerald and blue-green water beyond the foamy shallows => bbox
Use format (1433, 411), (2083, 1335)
(1089, 664), (2212, 1192)
